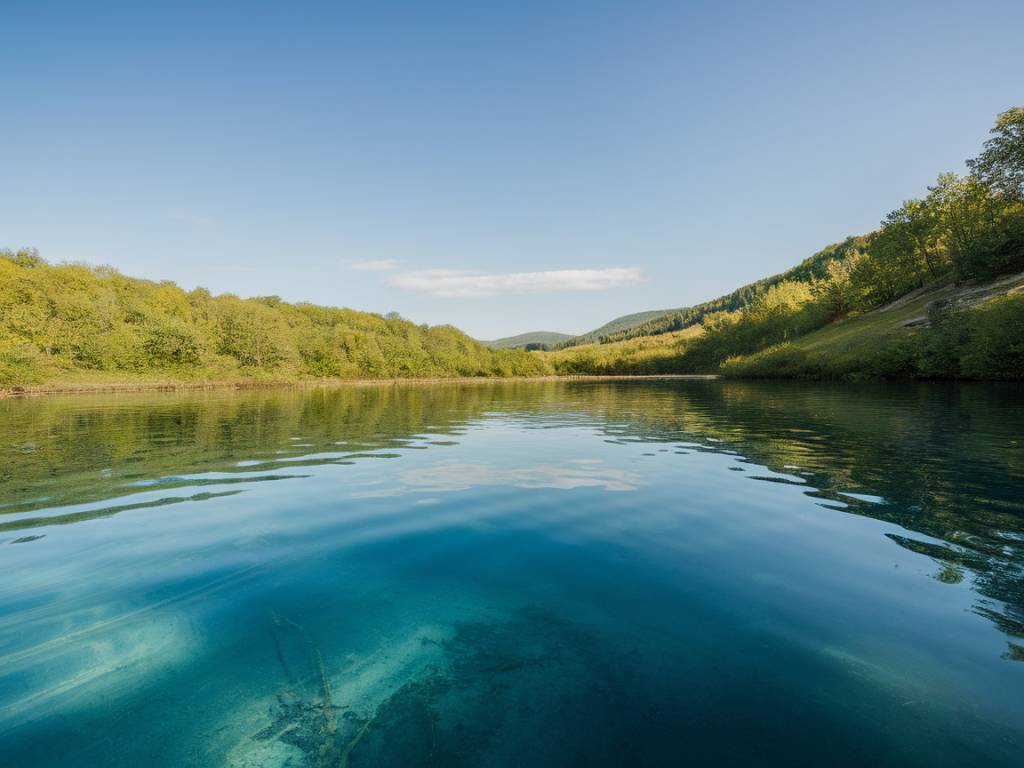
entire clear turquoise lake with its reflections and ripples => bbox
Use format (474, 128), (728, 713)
(0, 382), (1024, 766)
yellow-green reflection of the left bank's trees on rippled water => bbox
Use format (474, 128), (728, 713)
(0, 386), (503, 519)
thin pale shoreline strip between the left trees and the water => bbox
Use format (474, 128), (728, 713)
(0, 374), (721, 399)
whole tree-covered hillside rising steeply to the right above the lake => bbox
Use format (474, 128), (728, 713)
(550, 108), (1024, 379)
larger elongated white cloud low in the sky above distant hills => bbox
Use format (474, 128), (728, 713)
(388, 266), (643, 299)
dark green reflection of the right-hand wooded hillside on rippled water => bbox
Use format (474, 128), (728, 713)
(548, 381), (1024, 647)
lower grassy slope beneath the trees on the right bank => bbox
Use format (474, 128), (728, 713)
(547, 273), (1024, 380)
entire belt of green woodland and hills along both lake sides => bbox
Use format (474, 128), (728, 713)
(0, 108), (1024, 390)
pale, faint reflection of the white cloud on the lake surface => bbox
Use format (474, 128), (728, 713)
(373, 460), (641, 496)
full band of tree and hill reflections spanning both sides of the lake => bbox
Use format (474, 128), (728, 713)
(0, 381), (1024, 651)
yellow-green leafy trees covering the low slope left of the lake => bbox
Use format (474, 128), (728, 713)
(0, 251), (548, 386)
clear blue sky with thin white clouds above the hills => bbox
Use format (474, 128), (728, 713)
(0, 0), (1024, 338)
